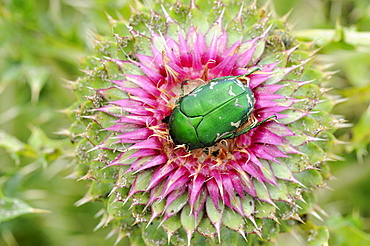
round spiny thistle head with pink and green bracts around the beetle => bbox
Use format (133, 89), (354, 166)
(71, 1), (342, 245)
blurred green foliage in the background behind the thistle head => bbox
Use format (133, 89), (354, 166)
(0, 0), (370, 246)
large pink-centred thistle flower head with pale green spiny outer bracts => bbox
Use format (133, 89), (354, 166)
(71, 1), (346, 244)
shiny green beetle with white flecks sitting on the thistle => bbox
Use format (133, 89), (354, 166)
(168, 69), (275, 150)
